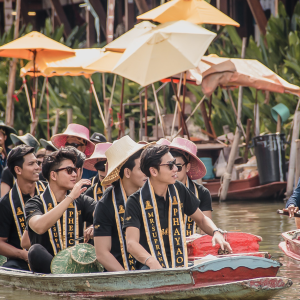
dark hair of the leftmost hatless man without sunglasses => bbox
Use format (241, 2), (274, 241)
(7, 144), (34, 178)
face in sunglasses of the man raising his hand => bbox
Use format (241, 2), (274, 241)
(50, 159), (77, 191)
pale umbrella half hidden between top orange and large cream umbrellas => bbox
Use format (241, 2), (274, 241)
(105, 21), (156, 52)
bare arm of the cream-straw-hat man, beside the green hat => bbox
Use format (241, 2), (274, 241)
(94, 236), (125, 272)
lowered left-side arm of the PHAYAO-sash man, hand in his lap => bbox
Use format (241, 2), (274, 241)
(126, 227), (162, 270)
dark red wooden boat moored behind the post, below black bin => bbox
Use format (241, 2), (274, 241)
(202, 175), (286, 200)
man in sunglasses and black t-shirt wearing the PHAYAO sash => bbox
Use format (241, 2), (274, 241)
(123, 145), (232, 269)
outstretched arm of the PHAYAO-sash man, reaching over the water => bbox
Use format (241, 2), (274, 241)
(190, 208), (232, 253)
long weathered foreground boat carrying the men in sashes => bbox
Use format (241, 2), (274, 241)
(0, 256), (292, 300)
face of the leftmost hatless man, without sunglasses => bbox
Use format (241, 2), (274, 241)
(15, 153), (40, 182)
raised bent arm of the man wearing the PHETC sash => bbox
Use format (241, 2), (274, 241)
(28, 179), (90, 234)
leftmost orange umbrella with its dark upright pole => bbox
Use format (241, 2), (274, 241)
(0, 31), (75, 122)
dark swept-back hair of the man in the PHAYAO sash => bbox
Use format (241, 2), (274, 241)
(141, 145), (170, 177)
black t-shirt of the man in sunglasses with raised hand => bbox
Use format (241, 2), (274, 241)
(25, 195), (96, 255)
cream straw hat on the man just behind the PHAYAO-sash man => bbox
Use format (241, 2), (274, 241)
(101, 135), (148, 186)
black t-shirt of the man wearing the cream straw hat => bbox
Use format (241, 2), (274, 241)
(94, 187), (124, 267)
